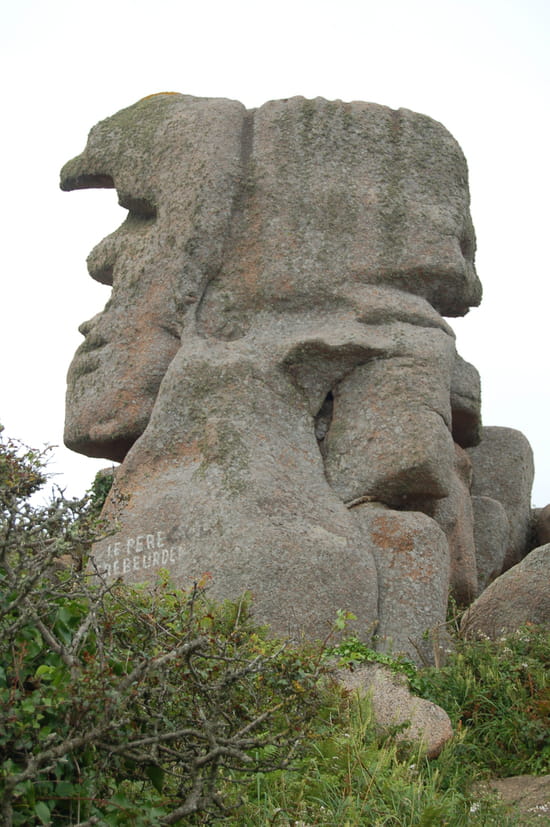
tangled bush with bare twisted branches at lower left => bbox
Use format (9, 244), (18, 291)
(0, 442), (324, 825)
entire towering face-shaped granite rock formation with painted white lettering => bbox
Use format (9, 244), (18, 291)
(62, 94), (494, 656)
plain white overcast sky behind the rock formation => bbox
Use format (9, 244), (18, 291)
(0, 0), (550, 506)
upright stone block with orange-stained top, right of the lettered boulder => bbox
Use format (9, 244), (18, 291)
(352, 503), (450, 662)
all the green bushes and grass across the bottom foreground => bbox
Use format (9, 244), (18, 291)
(0, 430), (550, 827)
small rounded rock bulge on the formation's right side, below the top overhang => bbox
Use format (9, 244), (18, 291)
(451, 354), (482, 448)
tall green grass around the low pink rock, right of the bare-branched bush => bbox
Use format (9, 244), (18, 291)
(221, 627), (550, 827)
